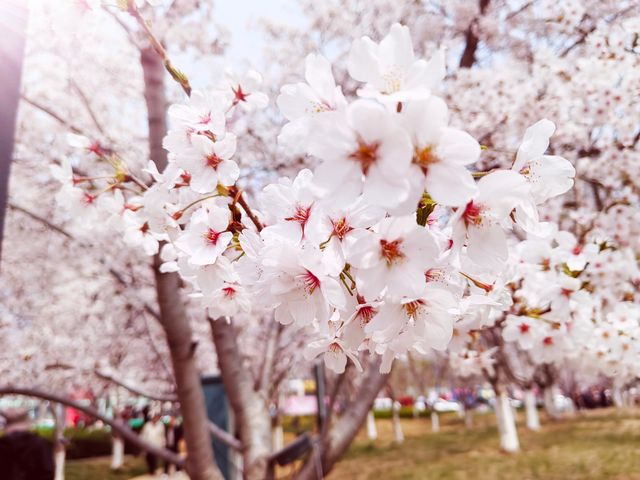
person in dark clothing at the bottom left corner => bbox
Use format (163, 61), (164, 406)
(0, 410), (55, 480)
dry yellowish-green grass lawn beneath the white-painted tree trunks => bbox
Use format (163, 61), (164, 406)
(329, 409), (640, 480)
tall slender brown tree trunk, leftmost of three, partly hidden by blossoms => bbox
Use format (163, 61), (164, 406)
(140, 47), (222, 480)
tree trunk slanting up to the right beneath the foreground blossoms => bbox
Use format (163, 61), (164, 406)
(297, 358), (388, 480)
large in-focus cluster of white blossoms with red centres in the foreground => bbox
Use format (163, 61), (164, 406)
(55, 24), (579, 372)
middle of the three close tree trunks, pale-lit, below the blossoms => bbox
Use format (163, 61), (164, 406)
(209, 318), (271, 480)
